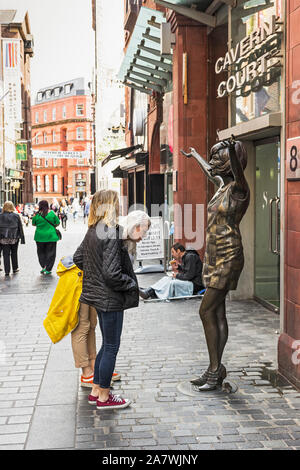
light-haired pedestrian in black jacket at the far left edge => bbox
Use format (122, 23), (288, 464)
(0, 201), (25, 276)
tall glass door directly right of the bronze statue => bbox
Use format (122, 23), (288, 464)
(255, 138), (280, 312)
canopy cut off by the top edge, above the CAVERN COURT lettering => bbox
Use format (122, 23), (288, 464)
(154, 0), (236, 28)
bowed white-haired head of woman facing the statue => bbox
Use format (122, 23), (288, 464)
(119, 211), (151, 263)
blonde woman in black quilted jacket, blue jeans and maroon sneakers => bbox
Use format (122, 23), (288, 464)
(73, 191), (139, 410)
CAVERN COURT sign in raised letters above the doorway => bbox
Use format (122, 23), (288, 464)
(215, 16), (282, 98)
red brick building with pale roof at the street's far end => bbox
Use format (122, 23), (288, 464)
(32, 78), (94, 201)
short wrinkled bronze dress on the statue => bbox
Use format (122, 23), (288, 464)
(203, 181), (250, 290)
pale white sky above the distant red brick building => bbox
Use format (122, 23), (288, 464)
(0, 0), (94, 98)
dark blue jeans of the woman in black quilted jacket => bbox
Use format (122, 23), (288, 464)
(94, 310), (124, 388)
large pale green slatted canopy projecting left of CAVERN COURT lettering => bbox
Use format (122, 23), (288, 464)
(118, 7), (173, 95)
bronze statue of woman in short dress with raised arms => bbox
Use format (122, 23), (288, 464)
(182, 136), (250, 391)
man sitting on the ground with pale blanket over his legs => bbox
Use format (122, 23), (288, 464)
(139, 243), (204, 299)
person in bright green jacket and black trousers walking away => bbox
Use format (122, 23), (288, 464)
(32, 201), (60, 274)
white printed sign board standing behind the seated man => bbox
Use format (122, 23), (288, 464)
(136, 217), (164, 261)
